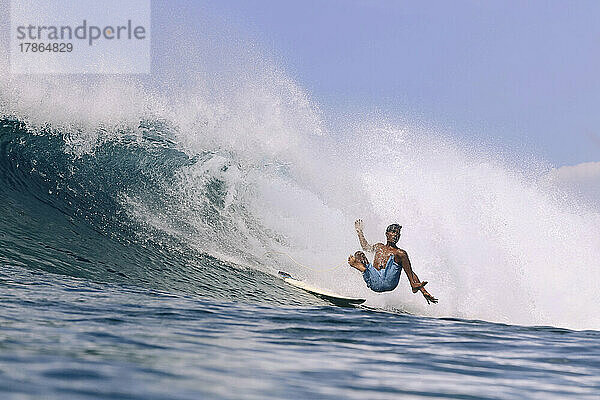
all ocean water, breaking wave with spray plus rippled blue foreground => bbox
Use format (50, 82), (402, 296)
(0, 6), (600, 399)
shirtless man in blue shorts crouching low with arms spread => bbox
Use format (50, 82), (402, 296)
(348, 219), (438, 304)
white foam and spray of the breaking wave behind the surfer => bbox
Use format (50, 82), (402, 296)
(0, 7), (600, 329)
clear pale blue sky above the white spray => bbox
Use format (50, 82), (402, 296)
(159, 0), (600, 166)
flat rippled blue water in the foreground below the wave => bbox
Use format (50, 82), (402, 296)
(0, 265), (600, 399)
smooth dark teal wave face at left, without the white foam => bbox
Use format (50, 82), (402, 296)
(0, 120), (272, 298)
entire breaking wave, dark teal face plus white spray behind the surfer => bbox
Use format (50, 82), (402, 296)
(0, 7), (600, 329)
